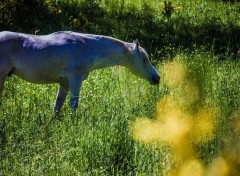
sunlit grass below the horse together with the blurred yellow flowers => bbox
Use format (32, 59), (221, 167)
(0, 52), (240, 175)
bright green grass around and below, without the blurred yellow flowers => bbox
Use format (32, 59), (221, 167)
(0, 52), (240, 175)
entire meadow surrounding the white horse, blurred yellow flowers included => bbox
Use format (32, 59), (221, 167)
(0, 0), (240, 175)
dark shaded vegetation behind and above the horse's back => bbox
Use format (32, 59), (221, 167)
(0, 0), (240, 58)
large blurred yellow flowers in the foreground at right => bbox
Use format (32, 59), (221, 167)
(130, 61), (240, 176)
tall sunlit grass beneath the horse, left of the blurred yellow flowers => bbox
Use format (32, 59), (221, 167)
(0, 67), (159, 175)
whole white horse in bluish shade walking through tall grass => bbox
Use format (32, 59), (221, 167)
(0, 31), (160, 113)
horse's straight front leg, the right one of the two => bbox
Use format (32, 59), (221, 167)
(69, 75), (83, 111)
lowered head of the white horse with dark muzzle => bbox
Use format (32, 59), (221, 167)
(128, 40), (160, 85)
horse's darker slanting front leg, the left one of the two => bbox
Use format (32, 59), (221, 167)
(53, 85), (69, 114)
